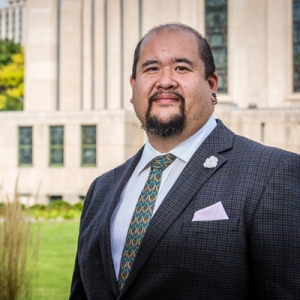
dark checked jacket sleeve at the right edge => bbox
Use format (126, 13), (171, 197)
(250, 153), (300, 300)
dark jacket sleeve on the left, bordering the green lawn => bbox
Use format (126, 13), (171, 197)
(69, 180), (97, 300)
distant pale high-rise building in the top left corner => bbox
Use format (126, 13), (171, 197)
(0, 0), (26, 45)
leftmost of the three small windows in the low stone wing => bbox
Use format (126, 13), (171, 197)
(19, 126), (32, 166)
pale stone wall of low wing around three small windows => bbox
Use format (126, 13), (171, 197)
(0, 110), (144, 204)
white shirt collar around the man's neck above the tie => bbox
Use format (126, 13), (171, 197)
(137, 116), (217, 174)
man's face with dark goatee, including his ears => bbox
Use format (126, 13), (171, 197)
(130, 28), (218, 138)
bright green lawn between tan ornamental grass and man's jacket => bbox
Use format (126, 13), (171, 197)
(32, 221), (79, 300)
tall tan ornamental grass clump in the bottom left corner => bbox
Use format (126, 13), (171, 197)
(0, 196), (38, 300)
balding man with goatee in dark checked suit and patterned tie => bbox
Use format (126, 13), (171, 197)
(70, 24), (300, 300)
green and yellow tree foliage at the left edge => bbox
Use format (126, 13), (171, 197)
(0, 39), (24, 110)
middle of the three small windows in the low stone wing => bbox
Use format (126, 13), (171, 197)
(50, 126), (64, 166)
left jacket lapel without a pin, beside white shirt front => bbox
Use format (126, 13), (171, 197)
(98, 148), (143, 297)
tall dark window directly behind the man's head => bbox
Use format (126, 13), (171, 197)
(205, 0), (228, 94)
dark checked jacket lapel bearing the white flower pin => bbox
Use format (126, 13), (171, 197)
(120, 122), (234, 295)
